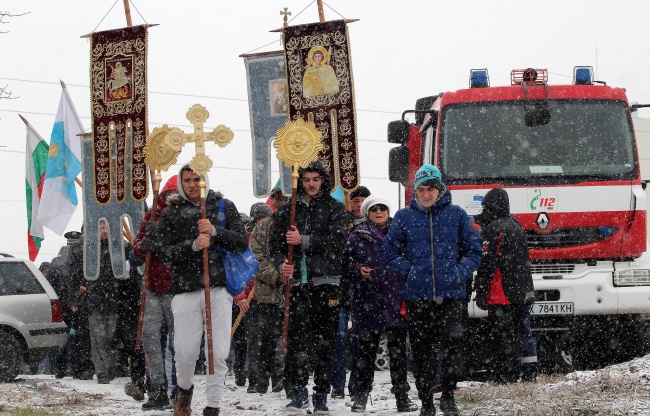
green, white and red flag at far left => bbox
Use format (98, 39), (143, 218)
(20, 116), (50, 261)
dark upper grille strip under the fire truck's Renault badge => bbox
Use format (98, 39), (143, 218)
(526, 227), (617, 250)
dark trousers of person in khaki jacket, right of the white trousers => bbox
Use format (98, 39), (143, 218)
(247, 301), (283, 388)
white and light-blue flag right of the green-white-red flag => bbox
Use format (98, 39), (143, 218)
(38, 82), (84, 235)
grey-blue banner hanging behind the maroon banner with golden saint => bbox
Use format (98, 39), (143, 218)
(242, 51), (291, 198)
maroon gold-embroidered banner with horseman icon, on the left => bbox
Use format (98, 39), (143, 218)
(90, 25), (148, 205)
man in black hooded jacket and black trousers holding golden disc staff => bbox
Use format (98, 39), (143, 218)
(270, 161), (348, 414)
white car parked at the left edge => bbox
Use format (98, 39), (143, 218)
(0, 253), (68, 382)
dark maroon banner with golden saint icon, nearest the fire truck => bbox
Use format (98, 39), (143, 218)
(283, 20), (360, 191)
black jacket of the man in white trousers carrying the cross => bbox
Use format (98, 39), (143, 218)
(157, 190), (248, 294)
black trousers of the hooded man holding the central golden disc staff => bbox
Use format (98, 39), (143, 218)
(285, 285), (339, 394)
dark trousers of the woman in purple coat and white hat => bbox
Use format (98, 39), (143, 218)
(354, 328), (410, 394)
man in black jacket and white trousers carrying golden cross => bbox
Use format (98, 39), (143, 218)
(158, 164), (248, 416)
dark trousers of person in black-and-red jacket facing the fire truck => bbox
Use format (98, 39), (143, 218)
(488, 305), (522, 383)
